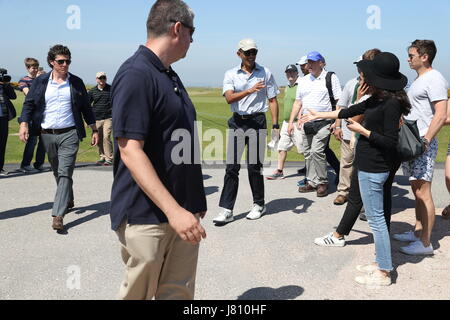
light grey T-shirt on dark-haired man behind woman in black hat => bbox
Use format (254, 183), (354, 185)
(406, 69), (448, 136)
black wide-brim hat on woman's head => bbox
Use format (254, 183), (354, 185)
(356, 52), (408, 91)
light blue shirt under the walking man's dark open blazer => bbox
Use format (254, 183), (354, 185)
(41, 73), (75, 129)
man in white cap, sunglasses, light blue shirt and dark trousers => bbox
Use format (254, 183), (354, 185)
(213, 39), (279, 225)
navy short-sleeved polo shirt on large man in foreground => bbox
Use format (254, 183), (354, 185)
(110, 46), (206, 230)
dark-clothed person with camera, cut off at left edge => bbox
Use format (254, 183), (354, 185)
(0, 70), (17, 176)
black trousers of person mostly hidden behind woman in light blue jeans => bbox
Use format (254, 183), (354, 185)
(336, 161), (401, 235)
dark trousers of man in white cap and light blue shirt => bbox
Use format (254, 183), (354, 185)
(219, 113), (267, 210)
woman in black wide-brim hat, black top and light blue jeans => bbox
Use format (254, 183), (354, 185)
(300, 52), (411, 286)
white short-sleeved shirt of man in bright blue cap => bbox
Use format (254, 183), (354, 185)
(296, 69), (342, 114)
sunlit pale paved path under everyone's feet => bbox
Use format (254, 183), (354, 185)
(0, 165), (450, 300)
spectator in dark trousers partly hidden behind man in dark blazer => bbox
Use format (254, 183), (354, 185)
(18, 58), (45, 173)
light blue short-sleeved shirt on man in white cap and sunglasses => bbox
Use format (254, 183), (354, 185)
(222, 63), (280, 115)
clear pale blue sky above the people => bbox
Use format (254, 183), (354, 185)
(0, 0), (450, 87)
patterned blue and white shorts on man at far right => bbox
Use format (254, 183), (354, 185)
(402, 139), (438, 182)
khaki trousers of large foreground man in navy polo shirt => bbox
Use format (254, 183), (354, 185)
(117, 222), (199, 300)
